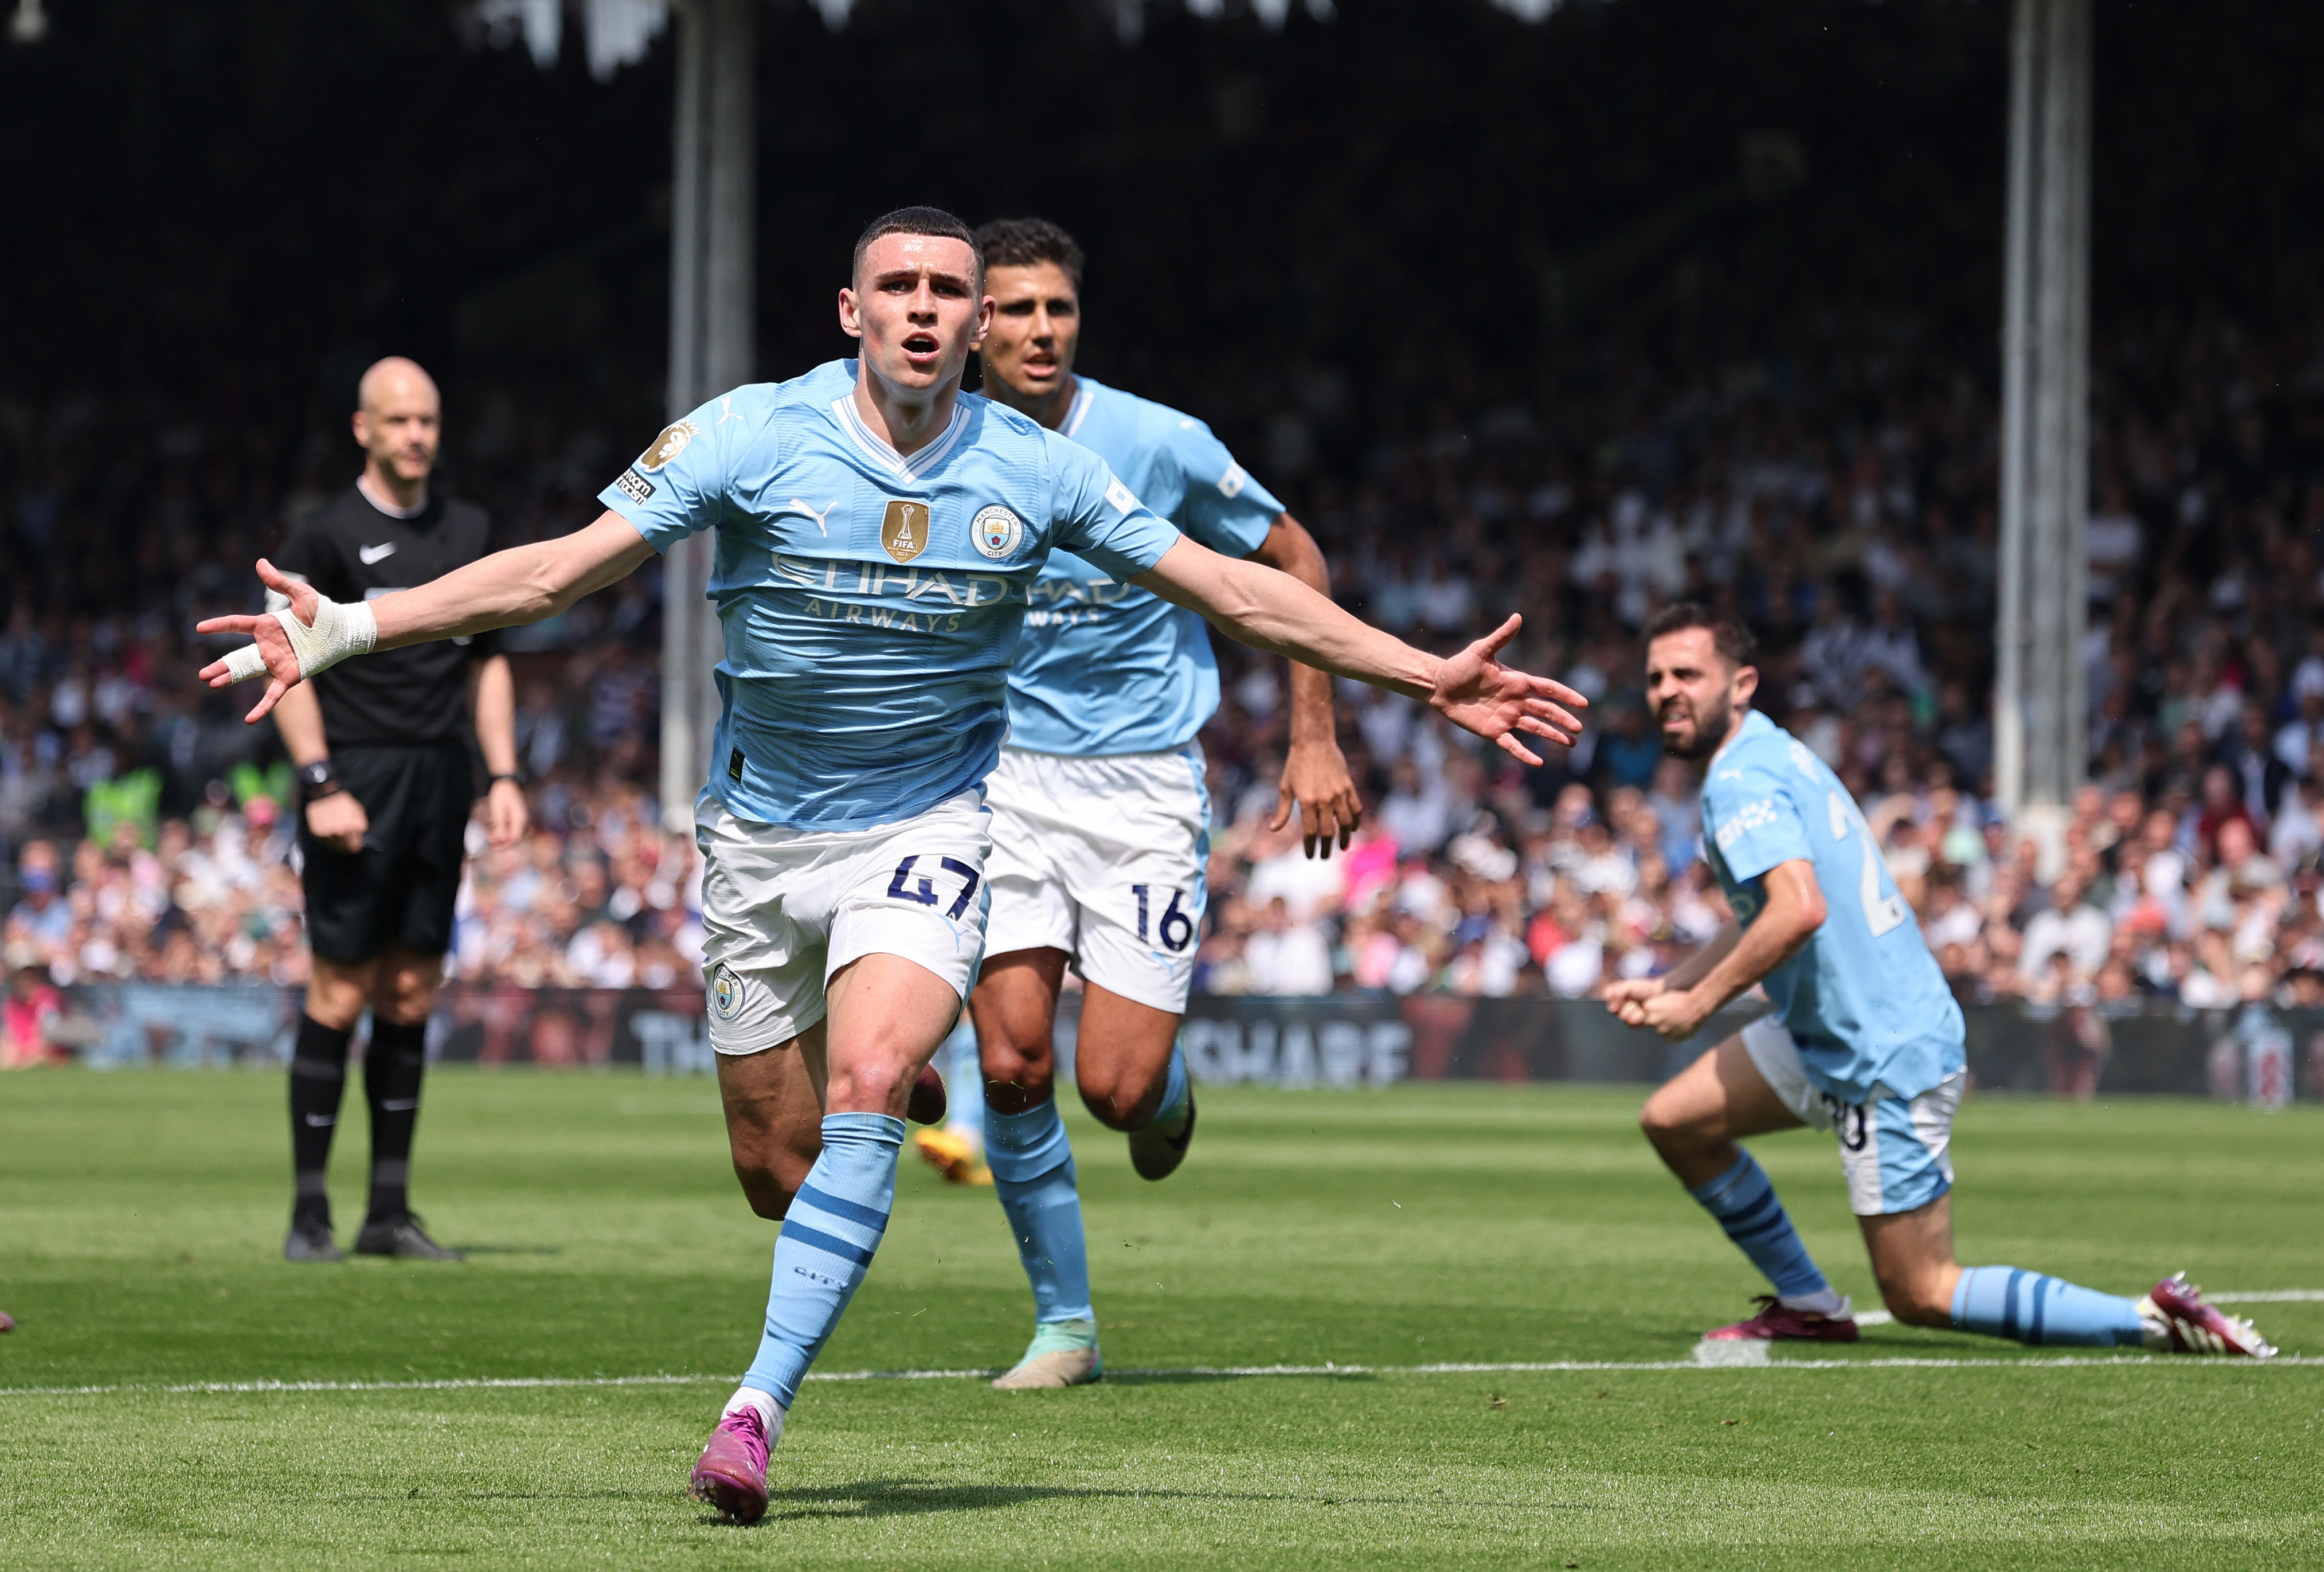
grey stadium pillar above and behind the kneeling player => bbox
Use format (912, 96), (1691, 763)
(1994, 0), (2092, 828)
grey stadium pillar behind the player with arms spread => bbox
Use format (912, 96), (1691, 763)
(662, 0), (758, 830)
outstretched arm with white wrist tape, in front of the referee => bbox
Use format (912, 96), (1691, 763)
(195, 511), (653, 721)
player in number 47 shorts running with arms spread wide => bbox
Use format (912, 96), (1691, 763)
(200, 207), (1580, 1521)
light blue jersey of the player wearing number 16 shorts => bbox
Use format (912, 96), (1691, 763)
(1008, 374), (1283, 758)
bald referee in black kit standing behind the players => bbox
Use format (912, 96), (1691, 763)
(267, 356), (525, 1260)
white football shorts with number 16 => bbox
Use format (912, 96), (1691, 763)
(985, 742), (1211, 1014)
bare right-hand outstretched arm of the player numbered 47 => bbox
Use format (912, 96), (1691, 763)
(1132, 537), (1590, 765)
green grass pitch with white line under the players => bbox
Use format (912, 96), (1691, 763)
(0, 1072), (2324, 1572)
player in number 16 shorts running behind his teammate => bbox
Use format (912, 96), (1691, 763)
(969, 218), (1362, 1389)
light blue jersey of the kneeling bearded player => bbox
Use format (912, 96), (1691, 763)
(1704, 709), (1966, 1102)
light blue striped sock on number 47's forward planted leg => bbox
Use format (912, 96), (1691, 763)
(741, 1114), (904, 1409)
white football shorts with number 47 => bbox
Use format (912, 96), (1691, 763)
(695, 791), (992, 1053)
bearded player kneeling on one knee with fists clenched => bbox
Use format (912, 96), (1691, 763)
(1606, 605), (2275, 1358)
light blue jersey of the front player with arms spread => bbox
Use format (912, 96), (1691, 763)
(600, 361), (1178, 830)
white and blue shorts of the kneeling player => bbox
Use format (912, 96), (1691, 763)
(1743, 1016), (1969, 1216)
